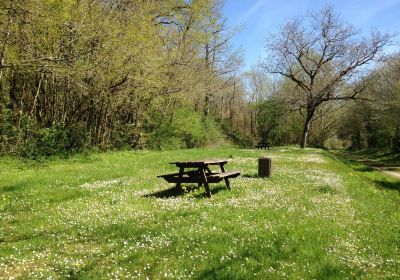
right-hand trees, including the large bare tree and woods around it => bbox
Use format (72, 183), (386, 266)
(247, 6), (400, 152)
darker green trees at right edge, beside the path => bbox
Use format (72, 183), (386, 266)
(338, 55), (400, 151)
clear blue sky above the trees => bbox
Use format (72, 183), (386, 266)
(223, 0), (400, 69)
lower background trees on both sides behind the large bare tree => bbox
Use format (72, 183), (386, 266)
(242, 51), (400, 152)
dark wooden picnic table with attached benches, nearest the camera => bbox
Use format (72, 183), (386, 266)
(158, 160), (240, 197)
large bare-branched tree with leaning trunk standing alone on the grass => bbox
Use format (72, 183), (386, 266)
(262, 7), (392, 148)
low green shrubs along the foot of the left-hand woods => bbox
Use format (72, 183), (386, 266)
(0, 106), (225, 158)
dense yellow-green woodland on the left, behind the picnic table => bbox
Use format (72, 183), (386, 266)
(0, 0), (247, 158)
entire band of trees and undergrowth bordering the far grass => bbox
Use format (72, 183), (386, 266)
(0, 0), (398, 157)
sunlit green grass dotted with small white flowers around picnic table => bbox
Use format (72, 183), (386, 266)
(0, 148), (400, 279)
